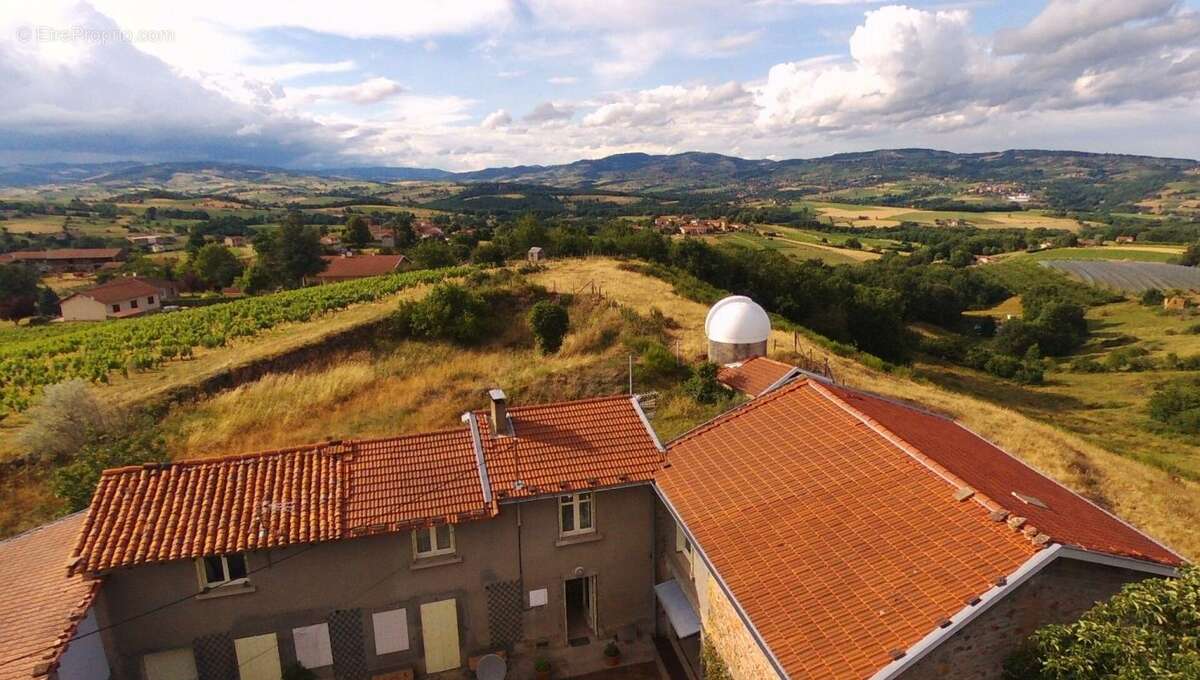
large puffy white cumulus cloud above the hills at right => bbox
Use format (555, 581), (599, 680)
(756, 0), (1200, 136)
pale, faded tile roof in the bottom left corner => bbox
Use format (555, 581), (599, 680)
(0, 513), (100, 680)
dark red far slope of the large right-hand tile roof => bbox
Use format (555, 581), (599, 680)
(826, 386), (1182, 565)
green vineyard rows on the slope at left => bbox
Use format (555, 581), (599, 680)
(0, 267), (467, 415)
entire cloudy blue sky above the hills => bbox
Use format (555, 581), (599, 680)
(0, 0), (1200, 170)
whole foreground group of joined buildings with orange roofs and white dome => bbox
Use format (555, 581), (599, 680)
(0, 297), (1183, 680)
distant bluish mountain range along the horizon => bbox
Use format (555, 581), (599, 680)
(0, 149), (1200, 192)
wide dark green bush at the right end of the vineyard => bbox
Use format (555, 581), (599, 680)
(392, 283), (488, 344)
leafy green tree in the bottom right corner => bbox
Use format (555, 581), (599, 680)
(1004, 566), (1200, 680)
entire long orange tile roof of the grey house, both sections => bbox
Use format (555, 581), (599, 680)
(74, 397), (662, 572)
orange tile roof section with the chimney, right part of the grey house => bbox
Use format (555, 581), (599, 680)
(476, 396), (662, 500)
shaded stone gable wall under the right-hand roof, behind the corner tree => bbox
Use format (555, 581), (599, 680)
(901, 559), (1148, 680)
